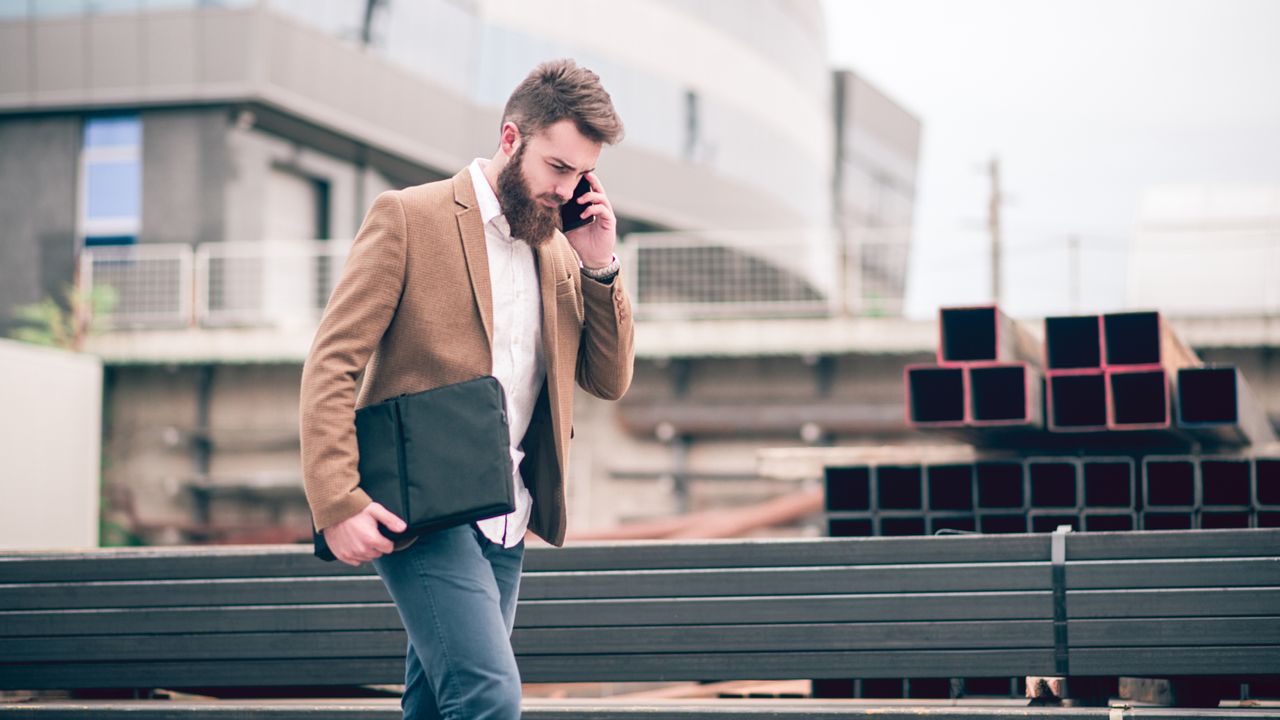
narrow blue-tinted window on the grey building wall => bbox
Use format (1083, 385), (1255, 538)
(79, 115), (142, 246)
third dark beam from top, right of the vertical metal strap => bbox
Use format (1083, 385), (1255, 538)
(1066, 588), (1280, 620)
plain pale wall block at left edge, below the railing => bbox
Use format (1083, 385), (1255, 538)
(0, 340), (102, 550)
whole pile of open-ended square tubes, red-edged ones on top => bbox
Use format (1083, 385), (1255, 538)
(827, 306), (1280, 536)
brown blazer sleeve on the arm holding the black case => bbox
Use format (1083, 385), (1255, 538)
(298, 192), (406, 530)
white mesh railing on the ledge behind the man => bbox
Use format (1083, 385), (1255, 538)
(81, 231), (906, 329)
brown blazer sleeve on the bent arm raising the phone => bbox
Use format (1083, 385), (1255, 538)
(577, 266), (635, 400)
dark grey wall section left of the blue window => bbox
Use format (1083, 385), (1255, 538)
(0, 117), (81, 336)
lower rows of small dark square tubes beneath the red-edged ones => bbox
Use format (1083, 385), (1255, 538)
(826, 452), (1280, 537)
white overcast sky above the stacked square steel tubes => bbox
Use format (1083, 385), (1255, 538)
(823, 0), (1280, 316)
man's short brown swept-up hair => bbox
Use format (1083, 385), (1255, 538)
(502, 59), (622, 145)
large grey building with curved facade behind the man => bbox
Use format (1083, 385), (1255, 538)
(0, 0), (920, 542)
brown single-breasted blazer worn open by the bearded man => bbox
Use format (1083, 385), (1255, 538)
(300, 169), (634, 546)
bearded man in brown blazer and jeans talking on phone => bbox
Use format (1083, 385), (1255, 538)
(301, 60), (634, 720)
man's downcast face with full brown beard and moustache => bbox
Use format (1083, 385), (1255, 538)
(498, 120), (600, 247)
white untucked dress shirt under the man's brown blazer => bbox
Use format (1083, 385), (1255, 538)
(470, 158), (547, 547)
